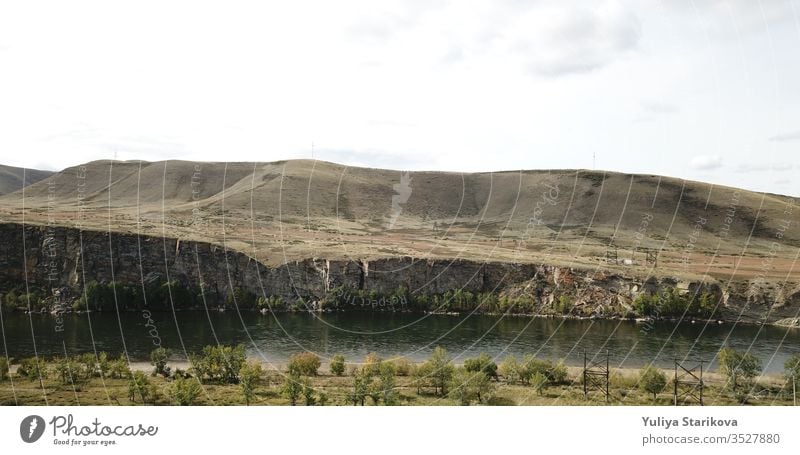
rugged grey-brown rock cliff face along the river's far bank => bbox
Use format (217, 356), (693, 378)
(0, 224), (800, 322)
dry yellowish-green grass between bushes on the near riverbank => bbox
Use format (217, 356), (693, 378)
(0, 362), (792, 406)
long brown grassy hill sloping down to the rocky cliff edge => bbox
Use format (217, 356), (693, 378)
(0, 160), (800, 280)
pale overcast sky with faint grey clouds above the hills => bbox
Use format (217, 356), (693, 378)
(0, 0), (800, 196)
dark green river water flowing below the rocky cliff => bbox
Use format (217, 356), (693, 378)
(0, 311), (800, 373)
